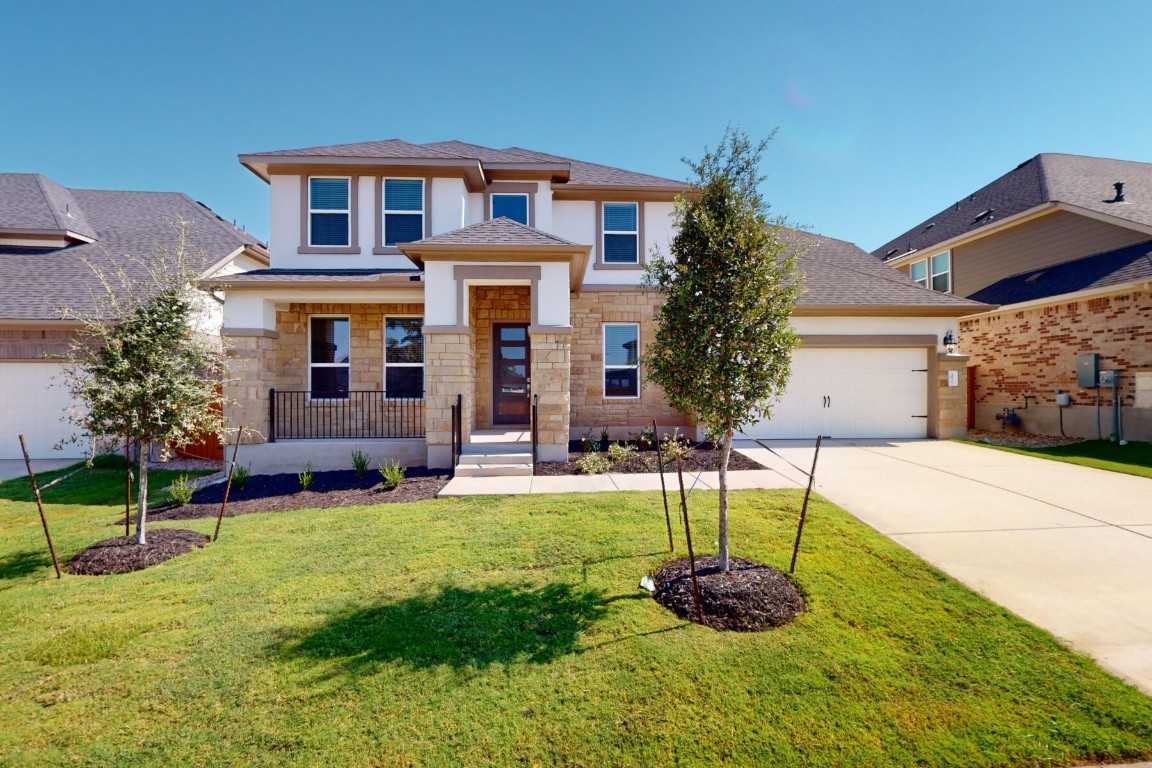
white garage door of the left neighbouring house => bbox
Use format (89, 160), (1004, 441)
(0, 363), (86, 458)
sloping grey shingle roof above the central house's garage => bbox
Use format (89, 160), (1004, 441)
(795, 233), (991, 317)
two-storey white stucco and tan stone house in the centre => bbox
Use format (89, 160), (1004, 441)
(210, 139), (979, 472)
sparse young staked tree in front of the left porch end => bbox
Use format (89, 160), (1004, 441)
(63, 220), (225, 545)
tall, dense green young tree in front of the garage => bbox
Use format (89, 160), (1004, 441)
(644, 128), (801, 571)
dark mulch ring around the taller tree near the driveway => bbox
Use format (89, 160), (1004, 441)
(652, 555), (805, 632)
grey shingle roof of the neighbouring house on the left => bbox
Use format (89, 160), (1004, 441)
(0, 174), (266, 321)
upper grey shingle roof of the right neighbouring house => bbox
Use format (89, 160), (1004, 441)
(872, 153), (1152, 260)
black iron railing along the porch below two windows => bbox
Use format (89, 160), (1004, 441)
(268, 389), (424, 442)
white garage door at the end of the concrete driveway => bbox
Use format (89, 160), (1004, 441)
(744, 348), (929, 440)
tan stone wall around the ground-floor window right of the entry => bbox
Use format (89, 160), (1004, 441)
(571, 287), (692, 439)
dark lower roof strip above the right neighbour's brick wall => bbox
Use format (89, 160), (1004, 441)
(972, 239), (1152, 305)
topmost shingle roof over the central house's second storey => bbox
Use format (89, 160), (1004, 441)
(241, 138), (688, 190)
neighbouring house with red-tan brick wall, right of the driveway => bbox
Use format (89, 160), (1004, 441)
(873, 154), (1152, 440)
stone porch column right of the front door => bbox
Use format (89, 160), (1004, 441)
(528, 326), (573, 462)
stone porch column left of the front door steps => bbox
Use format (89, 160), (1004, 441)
(424, 326), (476, 467)
